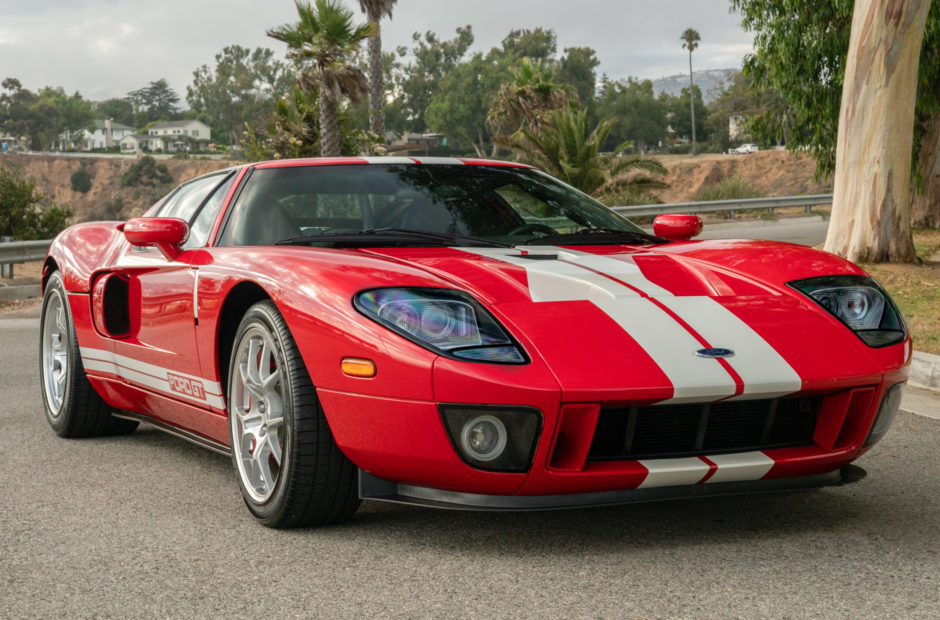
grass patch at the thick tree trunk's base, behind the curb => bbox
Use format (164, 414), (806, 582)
(862, 229), (940, 355)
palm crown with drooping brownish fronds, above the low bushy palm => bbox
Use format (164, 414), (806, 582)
(486, 57), (578, 137)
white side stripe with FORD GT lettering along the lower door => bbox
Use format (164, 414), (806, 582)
(79, 347), (225, 409)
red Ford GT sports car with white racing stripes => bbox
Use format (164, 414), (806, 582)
(40, 157), (911, 527)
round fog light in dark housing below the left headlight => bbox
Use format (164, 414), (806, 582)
(440, 405), (542, 471)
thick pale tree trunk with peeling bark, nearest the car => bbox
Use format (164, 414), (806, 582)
(825, 0), (930, 262)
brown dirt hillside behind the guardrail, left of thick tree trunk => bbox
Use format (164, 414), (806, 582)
(659, 151), (832, 204)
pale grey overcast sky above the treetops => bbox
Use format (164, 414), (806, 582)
(0, 0), (752, 100)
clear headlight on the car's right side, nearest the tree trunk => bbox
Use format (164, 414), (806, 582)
(787, 276), (907, 347)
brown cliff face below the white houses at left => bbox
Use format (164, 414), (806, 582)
(0, 155), (234, 223)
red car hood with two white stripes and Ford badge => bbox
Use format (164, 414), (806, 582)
(362, 241), (903, 402)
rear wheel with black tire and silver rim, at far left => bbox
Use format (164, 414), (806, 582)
(39, 271), (137, 437)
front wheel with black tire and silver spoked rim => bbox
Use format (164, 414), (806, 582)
(228, 301), (359, 528)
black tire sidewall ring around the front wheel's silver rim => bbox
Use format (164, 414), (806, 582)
(227, 302), (294, 523)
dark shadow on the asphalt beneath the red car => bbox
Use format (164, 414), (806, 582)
(110, 418), (935, 559)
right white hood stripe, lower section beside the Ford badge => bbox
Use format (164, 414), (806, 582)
(659, 297), (803, 399)
